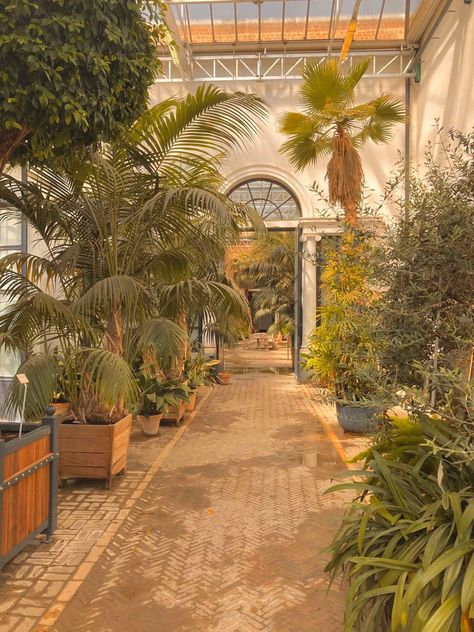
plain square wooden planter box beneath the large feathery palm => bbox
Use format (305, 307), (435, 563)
(59, 415), (132, 489)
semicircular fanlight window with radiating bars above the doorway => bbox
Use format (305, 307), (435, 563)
(229, 178), (300, 222)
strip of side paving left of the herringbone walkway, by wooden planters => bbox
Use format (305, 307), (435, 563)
(0, 414), (183, 632)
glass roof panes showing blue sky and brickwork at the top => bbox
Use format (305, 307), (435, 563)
(169, 0), (421, 45)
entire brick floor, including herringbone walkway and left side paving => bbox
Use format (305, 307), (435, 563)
(0, 370), (364, 632)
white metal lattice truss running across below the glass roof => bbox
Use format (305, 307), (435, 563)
(157, 49), (416, 83)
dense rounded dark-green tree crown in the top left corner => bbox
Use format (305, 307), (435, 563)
(0, 0), (168, 171)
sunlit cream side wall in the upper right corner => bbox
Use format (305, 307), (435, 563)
(412, 0), (474, 163)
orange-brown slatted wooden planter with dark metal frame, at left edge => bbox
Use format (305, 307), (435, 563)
(0, 417), (58, 568)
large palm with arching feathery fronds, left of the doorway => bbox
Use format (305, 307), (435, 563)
(0, 87), (266, 421)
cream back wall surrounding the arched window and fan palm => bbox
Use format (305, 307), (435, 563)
(151, 78), (405, 217)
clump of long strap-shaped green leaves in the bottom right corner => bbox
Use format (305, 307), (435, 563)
(327, 401), (474, 632)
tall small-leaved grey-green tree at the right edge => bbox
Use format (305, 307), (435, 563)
(378, 128), (474, 396)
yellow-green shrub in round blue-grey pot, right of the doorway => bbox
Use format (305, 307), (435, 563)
(305, 229), (383, 432)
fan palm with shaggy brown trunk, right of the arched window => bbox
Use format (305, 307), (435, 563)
(280, 59), (405, 225)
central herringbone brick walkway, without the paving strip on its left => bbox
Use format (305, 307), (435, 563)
(51, 374), (354, 632)
